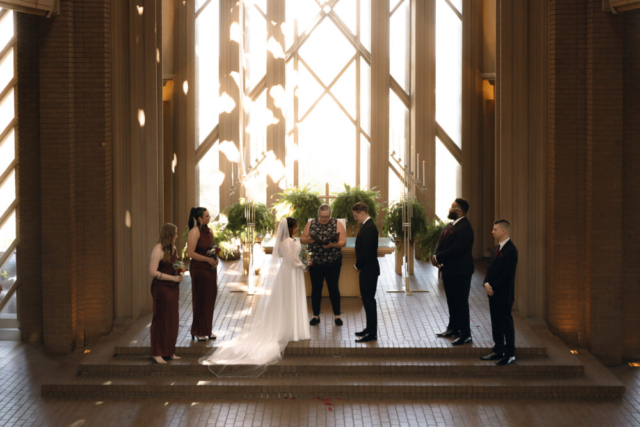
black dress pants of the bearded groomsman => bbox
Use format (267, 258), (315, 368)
(442, 272), (472, 337)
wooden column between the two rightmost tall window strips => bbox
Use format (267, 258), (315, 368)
(410, 0), (436, 220)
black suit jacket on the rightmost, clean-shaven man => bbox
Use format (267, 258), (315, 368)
(482, 239), (518, 302)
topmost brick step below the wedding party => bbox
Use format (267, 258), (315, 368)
(114, 341), (547, 358)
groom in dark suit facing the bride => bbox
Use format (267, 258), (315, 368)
(351, 202), (380, 343)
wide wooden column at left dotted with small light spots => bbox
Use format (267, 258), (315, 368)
(112, 0), (163, 318)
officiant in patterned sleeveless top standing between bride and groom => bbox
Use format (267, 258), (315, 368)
(300, 204), (347, 326)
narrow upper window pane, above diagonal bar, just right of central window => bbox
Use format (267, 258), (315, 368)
(389, 0), (410, 93)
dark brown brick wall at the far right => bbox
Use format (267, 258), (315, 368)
(546, 0), (640, 365)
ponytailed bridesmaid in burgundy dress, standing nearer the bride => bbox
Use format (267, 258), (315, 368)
(187, 208), (218, 341)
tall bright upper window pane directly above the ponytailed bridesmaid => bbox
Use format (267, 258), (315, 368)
(196, 1), (220, 146)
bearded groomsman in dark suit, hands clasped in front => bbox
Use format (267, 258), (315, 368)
(431, 198), (474, 345)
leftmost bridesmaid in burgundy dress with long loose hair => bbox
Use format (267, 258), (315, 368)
(149, 224), (182, 363)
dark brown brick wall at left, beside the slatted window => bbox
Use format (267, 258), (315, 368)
(18, 0), (113, 353)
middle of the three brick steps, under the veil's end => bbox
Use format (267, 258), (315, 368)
(79, 357), (584, 379)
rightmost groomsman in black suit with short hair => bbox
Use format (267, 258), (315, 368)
(480, 219), (518, 366)
